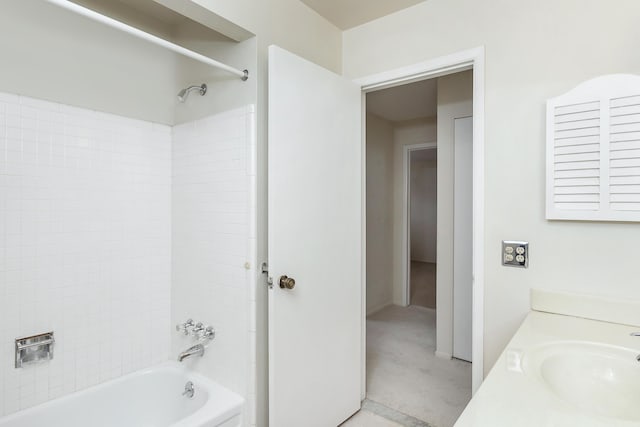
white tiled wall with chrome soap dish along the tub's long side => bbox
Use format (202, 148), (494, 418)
(0, 94), (172, 416)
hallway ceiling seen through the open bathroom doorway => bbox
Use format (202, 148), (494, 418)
(367, 79), (438, 122)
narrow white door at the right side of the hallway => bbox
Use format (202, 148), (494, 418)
(453, 117), (473, 362)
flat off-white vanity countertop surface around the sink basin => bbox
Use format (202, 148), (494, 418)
(455, 311), (640, 427)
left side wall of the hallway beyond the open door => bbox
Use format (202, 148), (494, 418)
(366, 114), (394, 314)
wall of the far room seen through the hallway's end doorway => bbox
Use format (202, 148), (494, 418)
(410, 156), (438, 263)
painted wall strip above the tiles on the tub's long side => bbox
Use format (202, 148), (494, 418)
(0, 0), (177, 124)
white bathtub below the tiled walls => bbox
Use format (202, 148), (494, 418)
(0, 362), (244, 427)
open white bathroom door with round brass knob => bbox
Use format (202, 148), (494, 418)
(268, 46), (362, 427)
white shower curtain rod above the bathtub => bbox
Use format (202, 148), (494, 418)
(45, 0), (249, 81)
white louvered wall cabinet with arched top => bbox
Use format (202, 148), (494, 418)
(547, 74), (640, 221)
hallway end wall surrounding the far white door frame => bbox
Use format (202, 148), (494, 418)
(393, 117), (437, 305)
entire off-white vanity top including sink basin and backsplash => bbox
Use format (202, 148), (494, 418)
(455, 290), (640, 427)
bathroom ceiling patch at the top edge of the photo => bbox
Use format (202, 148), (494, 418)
(301, 0), (426, 30)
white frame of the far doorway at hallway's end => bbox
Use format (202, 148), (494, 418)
(402, 142), (438, 307)
